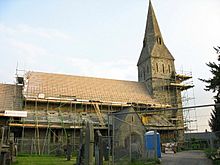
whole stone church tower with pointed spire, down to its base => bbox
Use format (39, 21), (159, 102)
(137, 1), (192, 143)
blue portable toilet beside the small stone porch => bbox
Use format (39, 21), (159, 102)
(144, 131), (161, 158)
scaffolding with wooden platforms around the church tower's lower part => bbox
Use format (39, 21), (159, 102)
(142, 68), (197, 141)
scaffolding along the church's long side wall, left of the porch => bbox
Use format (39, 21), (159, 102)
(9, 83), (134, 155)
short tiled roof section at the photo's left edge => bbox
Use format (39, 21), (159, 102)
(0, 84), (22, 110)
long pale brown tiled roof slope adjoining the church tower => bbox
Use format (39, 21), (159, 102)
(23, 72), (161, 104)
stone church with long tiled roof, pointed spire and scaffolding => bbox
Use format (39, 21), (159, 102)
(0, 2), (192, 152)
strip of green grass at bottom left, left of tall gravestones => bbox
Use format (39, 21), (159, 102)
(12, 155), (76, 165)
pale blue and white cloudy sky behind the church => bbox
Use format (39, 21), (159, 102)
(0, 0), (220, 131)
